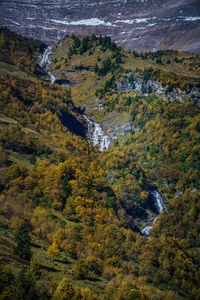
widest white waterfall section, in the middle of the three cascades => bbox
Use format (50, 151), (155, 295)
(83, 115), (111, 152)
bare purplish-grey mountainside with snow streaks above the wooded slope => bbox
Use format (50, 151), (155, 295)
(0, 0), (200, 52)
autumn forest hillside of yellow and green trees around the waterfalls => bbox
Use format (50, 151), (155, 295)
(0, 28), (200, 300)
